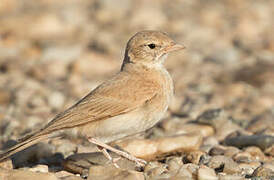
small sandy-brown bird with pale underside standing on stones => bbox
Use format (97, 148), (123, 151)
(0, 30), (185, 167)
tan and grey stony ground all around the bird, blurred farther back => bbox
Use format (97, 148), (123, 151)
(0, 0), (274, 180)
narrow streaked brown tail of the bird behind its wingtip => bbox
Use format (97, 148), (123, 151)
(0, 133), (49, 162)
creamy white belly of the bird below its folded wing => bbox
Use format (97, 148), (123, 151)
(79, 108), (166, 143)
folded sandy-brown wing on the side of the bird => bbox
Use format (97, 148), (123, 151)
(41, 72), (160, 134)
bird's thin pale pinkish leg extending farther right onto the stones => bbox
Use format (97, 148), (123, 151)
(88, 138), (147, 167)
